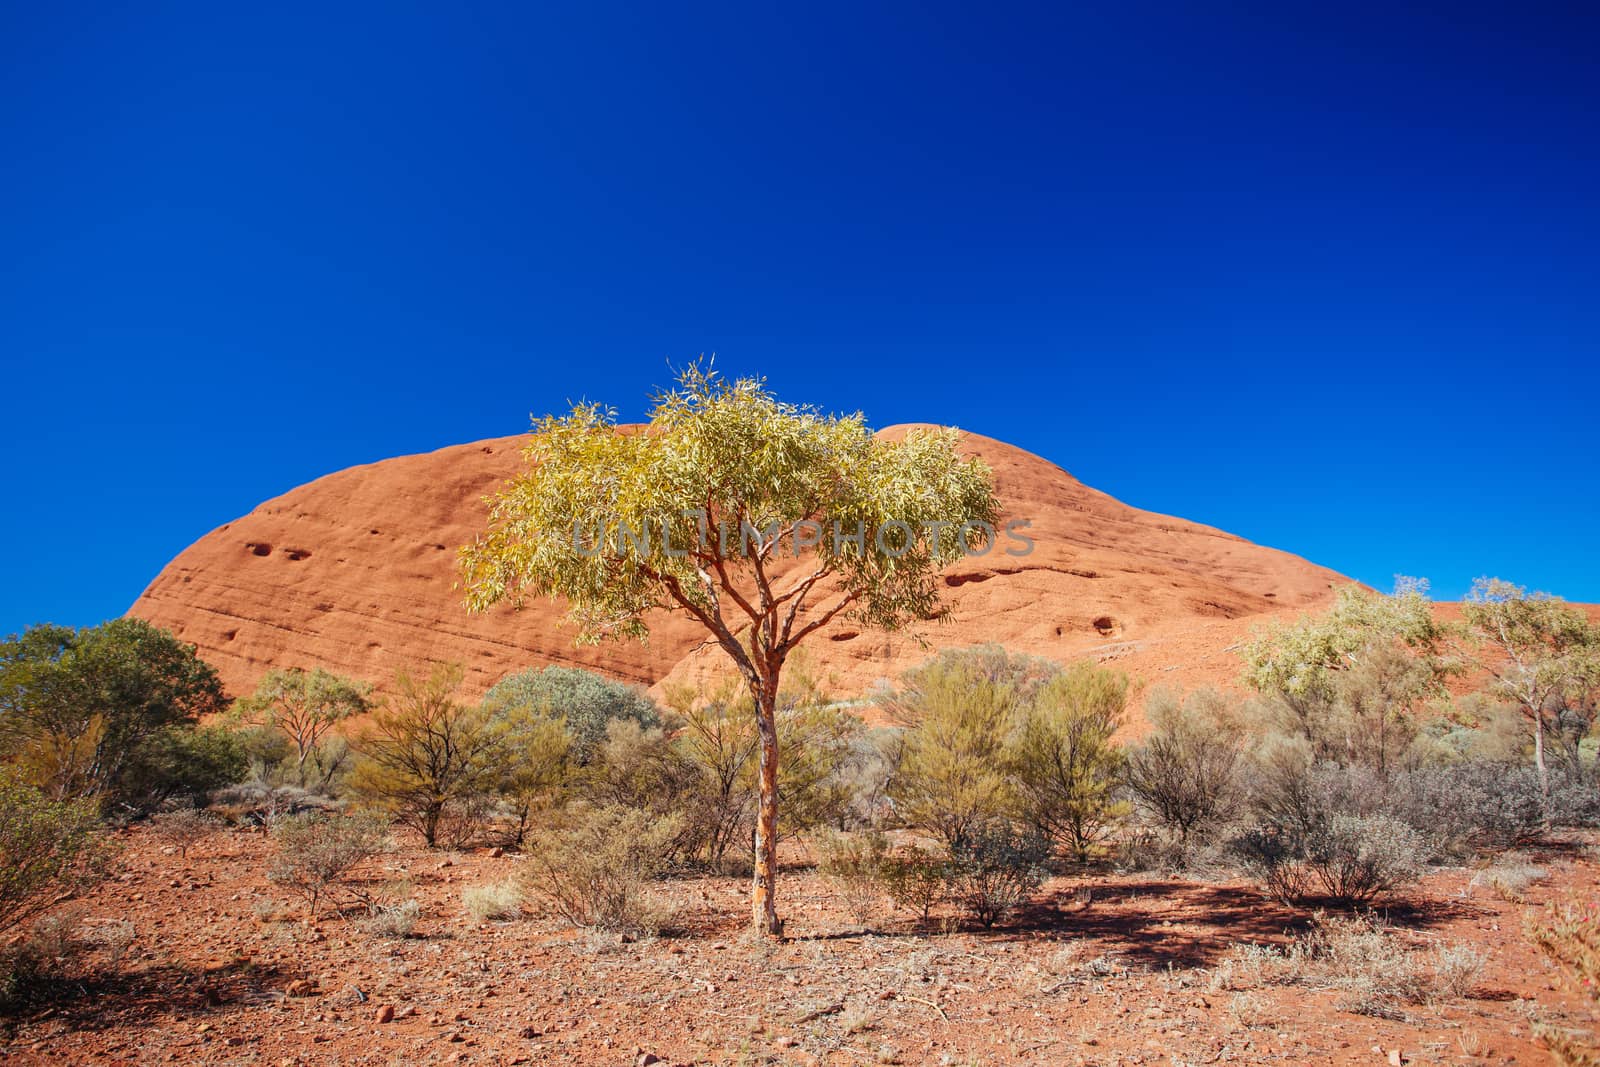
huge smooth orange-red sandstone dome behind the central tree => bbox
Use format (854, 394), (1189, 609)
(130, 427), (1349, 696)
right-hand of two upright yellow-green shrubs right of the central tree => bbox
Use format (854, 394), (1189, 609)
(1008, 662), (1128, 861)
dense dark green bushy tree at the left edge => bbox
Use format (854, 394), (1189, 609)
(0, 619), (224, 808)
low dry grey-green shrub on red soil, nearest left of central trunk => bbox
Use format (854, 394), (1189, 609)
(525, 799), (682, 933)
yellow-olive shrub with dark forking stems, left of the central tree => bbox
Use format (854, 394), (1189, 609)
(350, 664), (501, 848)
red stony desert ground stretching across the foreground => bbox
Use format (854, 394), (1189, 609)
(0, 827), (1600, 1067)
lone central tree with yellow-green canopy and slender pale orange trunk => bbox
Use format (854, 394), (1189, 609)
(461, 366), (998, 933)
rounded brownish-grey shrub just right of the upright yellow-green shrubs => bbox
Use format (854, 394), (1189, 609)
(1125, 689), (1243, 843)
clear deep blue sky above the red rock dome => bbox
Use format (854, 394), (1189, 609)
(0, 3), (1600, 633)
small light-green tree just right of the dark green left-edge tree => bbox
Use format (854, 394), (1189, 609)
(234, 667), (371, 789)
